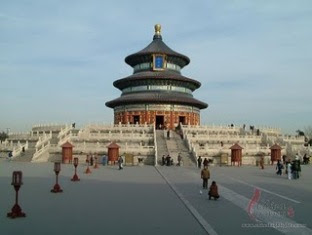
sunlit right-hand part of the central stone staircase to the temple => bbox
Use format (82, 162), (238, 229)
(166, 131), (196, 167)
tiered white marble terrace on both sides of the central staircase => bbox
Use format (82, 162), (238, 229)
(0, 124), (308, 164)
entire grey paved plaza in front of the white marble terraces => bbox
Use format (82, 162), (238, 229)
(0, 159), (312, 235)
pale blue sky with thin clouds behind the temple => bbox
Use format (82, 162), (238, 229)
(0, 0), (312, 134)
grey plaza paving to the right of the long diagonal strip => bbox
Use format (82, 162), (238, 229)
(158, 166), (312, 234)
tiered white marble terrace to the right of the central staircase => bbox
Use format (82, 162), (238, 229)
(182, 125), (308, 165)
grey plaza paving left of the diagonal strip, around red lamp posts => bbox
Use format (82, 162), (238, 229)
(0, 161), (207, 235)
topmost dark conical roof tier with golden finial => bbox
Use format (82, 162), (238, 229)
(125, 24), (190, 68)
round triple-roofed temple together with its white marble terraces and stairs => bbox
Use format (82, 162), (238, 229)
(0, 25), (312, 167)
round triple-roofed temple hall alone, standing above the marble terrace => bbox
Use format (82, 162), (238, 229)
(106, 24), (208, 129)
